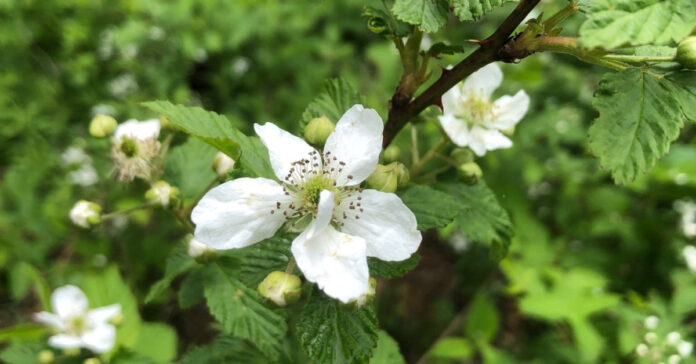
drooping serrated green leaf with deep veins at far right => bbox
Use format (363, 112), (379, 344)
(589, 68), (683, 184)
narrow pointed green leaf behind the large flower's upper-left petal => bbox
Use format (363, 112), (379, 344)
(143, 101), (275, 178)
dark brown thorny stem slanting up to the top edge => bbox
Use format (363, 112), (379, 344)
(383, 0), (541, 147)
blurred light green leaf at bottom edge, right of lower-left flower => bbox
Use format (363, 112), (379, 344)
(133, 322), (177, 362)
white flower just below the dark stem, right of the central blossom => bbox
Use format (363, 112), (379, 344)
(439, 63), (529, 156)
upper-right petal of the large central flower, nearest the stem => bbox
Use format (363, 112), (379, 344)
(324, 105), (384, 186)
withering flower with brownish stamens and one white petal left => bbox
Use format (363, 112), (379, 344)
(111, 119), (161, 182)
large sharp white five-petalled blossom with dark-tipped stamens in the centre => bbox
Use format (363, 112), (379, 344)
(191, 105), (421, 303)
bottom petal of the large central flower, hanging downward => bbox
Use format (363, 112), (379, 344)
(292, 222), (369, 303)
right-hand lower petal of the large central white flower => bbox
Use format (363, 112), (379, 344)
(336, 190), (422, 261)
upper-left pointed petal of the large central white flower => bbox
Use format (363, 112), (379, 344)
(254, 123), (321, 181)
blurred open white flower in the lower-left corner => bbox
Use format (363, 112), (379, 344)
(35, 285), (121, 353)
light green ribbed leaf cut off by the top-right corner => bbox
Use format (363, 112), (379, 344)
(580, 0), (696, 49)
